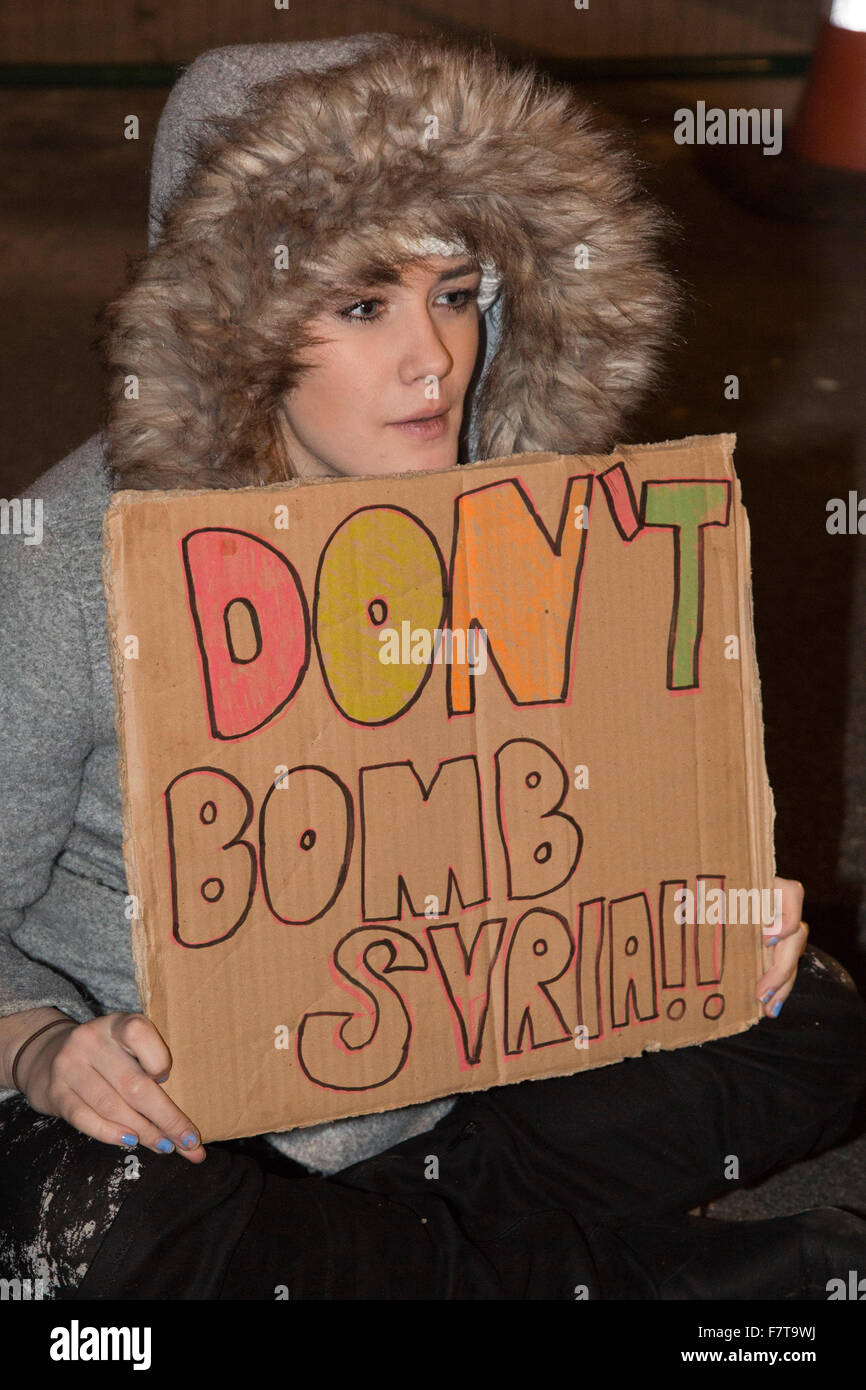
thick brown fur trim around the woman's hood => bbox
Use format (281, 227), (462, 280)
(106, 35), (680, 488)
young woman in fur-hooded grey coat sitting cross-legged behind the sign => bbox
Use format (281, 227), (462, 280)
(0, 38), (866, 1300)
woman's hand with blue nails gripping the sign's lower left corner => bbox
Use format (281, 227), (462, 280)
(18, 1013), (206, 1163)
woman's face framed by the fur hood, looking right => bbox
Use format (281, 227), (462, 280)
(281, 256), (481, 477)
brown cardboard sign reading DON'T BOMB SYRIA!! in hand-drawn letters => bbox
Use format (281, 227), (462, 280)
(104, 435), (774, 1141)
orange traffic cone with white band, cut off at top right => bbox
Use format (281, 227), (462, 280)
(790, 0), (866, 172)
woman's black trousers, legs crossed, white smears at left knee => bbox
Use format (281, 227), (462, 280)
(0, 948), (866, 1300)
